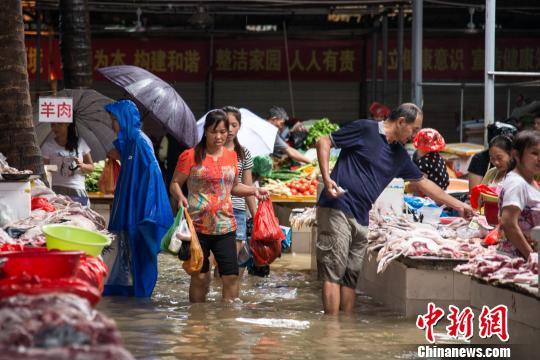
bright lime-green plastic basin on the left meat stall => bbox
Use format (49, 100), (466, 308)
(42, 224), (111, 256)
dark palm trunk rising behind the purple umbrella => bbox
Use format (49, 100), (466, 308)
(60, 0), (92, 89)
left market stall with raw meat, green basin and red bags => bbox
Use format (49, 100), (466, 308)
(0, 154), (133, 360)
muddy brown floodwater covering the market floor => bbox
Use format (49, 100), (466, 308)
(98, 254), (425, 360)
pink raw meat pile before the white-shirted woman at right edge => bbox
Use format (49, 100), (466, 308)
(454, 252), (538, 287)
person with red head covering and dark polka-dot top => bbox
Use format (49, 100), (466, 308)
(413, 128), (450, 190)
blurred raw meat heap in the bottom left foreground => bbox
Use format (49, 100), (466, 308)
(0, 294), (133, 359)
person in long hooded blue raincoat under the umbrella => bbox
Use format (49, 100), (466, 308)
(104, 100), (173, 297)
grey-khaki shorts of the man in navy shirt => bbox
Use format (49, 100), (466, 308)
(317, 207), (368, 289)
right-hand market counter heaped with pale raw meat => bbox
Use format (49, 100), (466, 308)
(359, 205), (539, 324)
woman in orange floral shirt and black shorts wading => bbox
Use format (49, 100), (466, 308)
(170, 110), (268, 302)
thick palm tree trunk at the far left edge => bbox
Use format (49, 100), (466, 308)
(0, 0), (44, 175)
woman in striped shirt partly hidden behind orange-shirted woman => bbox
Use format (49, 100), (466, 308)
(223, 106), (257, 276)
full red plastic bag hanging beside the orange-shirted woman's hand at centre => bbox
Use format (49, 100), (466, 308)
(250, 199), (285, 265)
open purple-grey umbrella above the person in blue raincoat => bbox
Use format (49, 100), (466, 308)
(98, 65), (198, 147)
